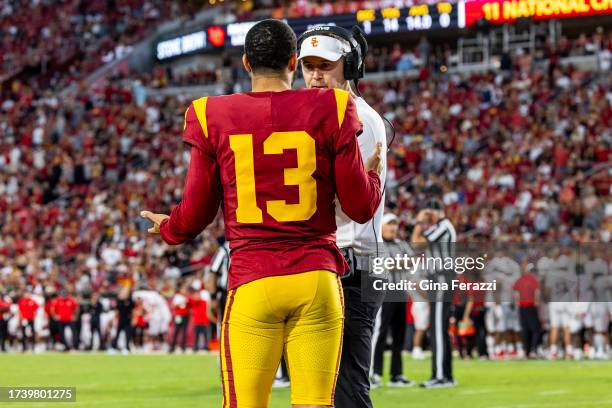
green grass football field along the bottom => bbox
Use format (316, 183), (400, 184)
(0, 354), (612, 408)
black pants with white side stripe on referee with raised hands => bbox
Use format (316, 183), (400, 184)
(429, 296), (453, 380)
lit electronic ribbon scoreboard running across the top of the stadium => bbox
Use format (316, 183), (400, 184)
(156, 0), (612, 60)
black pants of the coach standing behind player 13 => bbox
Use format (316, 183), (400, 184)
(334, 279), (383, 408)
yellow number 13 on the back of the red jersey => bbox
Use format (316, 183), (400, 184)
(229, 131), (317, 224)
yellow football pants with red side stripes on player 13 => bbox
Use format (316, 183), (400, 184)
(220, 270), (344, 408)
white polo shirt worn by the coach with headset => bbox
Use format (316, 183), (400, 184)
(336, 98), (387, 253)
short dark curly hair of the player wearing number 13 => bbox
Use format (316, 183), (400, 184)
(244, 19), (297, 72)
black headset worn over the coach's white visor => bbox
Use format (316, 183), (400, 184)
(298, 26), (368, 83)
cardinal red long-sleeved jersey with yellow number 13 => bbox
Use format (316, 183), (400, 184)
(161, 89), (381, 289)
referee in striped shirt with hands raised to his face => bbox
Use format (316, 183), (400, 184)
(412, 199), (457, 388)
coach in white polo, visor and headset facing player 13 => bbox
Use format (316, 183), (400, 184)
(298, 26), (387, 408)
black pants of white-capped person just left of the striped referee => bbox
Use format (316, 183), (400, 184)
(374, 302), (406, 377)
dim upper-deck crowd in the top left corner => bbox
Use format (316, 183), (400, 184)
(0, 0), (179, 89)
